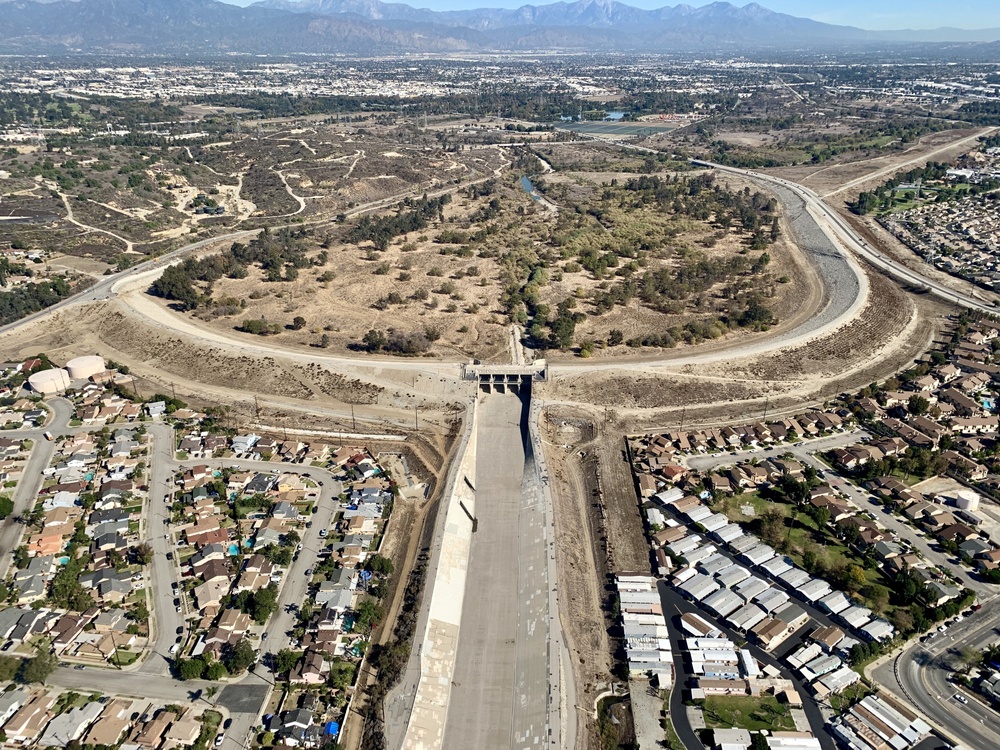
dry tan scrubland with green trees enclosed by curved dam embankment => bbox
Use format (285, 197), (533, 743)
(146, 145), (798, 360)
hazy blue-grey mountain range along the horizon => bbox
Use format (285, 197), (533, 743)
(0, 0), (1000, 55)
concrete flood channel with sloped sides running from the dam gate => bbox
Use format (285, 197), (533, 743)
(396, 384), (563, 750)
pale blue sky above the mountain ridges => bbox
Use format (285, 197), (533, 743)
(219, 0), (1000, 29)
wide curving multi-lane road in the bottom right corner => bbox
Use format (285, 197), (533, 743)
(872, 607), (1000, 750)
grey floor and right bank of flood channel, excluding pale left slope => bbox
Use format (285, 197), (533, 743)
(444, 386), (557, 750)
